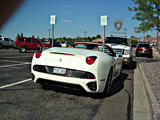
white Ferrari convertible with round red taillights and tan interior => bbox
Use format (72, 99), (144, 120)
(31, 42), (122, 94)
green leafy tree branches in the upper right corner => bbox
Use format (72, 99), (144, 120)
(128, 0), (160, 45)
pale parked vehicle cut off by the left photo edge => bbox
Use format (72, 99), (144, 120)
(0, 37), (14, 49)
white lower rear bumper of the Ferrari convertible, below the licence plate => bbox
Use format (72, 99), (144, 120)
(32, 71), (104, 93)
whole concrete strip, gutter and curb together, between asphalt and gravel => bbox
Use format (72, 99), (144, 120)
(133, 48), (160, 120)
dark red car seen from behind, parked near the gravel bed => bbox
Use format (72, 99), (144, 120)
(136, 43), (153, 58)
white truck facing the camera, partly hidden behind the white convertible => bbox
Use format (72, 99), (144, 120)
(105, 36), (132, 65)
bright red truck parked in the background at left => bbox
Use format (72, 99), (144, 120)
(14, 37), (52, 52)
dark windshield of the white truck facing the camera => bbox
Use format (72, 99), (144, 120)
(105, 37), (130, 46)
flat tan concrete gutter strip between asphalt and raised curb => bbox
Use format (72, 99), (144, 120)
(133, 65), (153, 120)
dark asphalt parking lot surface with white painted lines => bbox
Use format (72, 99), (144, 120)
(0, 49), (136, 120)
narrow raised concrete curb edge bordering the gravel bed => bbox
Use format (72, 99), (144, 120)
(134, 64), (160, 120)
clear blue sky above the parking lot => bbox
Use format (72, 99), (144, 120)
(0, 0), (156, 40)
